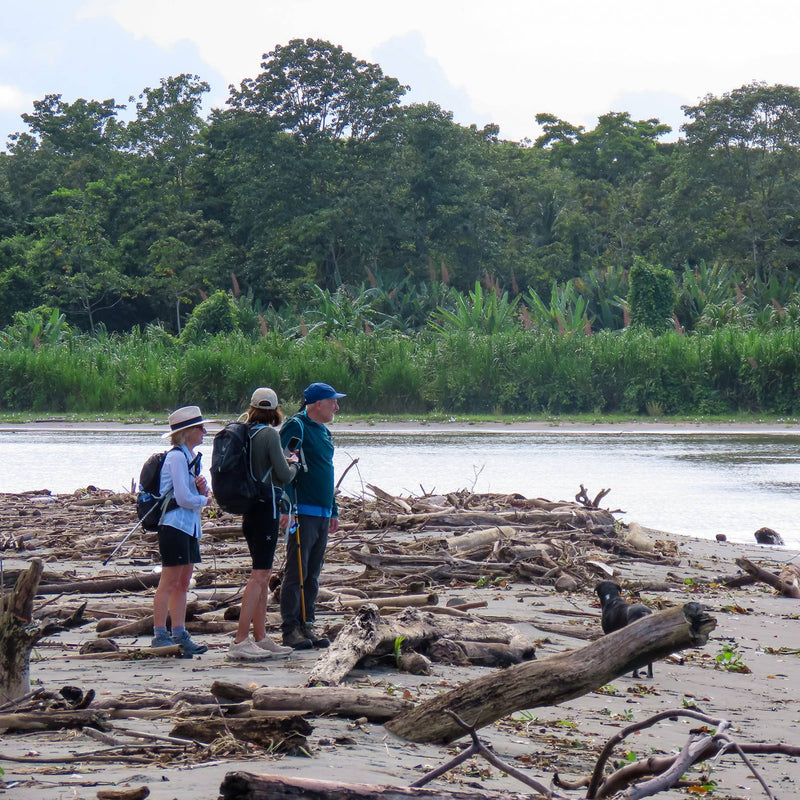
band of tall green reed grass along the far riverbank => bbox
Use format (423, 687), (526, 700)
(0, 327), (800, 416)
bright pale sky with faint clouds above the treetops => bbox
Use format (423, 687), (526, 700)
(0, 0), (800, 147)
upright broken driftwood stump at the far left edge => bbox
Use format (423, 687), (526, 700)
(0, 558), (42, 703)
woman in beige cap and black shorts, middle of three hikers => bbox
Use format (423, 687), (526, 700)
(228, 387), (297, 661)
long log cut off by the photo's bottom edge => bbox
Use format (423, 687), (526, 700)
(219, 772), (519, 800)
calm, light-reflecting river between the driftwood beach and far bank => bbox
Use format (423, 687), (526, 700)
(0, 424), (800, 548)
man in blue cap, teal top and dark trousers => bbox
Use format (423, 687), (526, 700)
(281, 383), (345, 650)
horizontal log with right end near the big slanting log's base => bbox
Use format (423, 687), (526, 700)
(253, 686), (414, 722)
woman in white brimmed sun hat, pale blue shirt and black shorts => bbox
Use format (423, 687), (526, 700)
(152, 406), (210, 656)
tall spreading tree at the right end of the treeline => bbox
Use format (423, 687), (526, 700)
(675, 83), (800, 283)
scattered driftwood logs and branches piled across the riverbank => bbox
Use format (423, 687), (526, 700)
(0, 486), (800, 798)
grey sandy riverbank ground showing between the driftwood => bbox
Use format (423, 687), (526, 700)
(0, 490), (800, 800)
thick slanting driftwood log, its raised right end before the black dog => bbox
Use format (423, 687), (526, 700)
(386, 603), (717, 743)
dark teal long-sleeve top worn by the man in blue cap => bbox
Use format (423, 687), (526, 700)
(281, 411), (339, 517)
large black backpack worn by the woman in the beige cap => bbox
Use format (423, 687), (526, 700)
(211, 422), (272, 514)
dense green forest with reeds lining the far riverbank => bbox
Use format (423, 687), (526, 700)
(0, 40), (800, 413)
